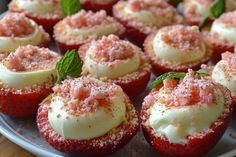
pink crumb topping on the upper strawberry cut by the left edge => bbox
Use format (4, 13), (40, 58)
(0, 13), (35, 37)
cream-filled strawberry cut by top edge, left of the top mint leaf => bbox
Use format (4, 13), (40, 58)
(9, 0), (63, 34)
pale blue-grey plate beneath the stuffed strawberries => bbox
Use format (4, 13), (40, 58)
(0, 14), (236, 157)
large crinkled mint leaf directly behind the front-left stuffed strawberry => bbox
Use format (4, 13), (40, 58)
(56, 50), (83, 83)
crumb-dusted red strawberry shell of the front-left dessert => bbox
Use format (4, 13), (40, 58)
(37, 94), (139, 155)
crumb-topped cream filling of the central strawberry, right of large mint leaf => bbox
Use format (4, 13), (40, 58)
(84, 35), (140, 79)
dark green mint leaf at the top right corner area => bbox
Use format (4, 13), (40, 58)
(210, 0), (225, 17)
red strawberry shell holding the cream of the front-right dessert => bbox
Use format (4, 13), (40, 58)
(141, 85), (233, 157)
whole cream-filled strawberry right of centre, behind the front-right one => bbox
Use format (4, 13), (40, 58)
(144, 25), (212, 74)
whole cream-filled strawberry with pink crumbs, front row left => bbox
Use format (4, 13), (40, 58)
(37, 77), (139, 155)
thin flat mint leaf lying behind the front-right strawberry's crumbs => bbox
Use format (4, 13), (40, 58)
(151, 72), (186, 88)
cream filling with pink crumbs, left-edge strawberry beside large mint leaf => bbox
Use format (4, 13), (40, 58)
(0, 45), (60, 89)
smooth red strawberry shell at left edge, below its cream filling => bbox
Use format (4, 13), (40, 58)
(0, 87), (51, 117)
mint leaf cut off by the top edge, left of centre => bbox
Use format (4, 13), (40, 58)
(60, 0), (81, 16)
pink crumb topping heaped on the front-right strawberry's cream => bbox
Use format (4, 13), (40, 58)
(164, 70), (215, 107)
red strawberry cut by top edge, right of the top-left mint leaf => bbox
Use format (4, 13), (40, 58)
(80, 0), (118, 15)
